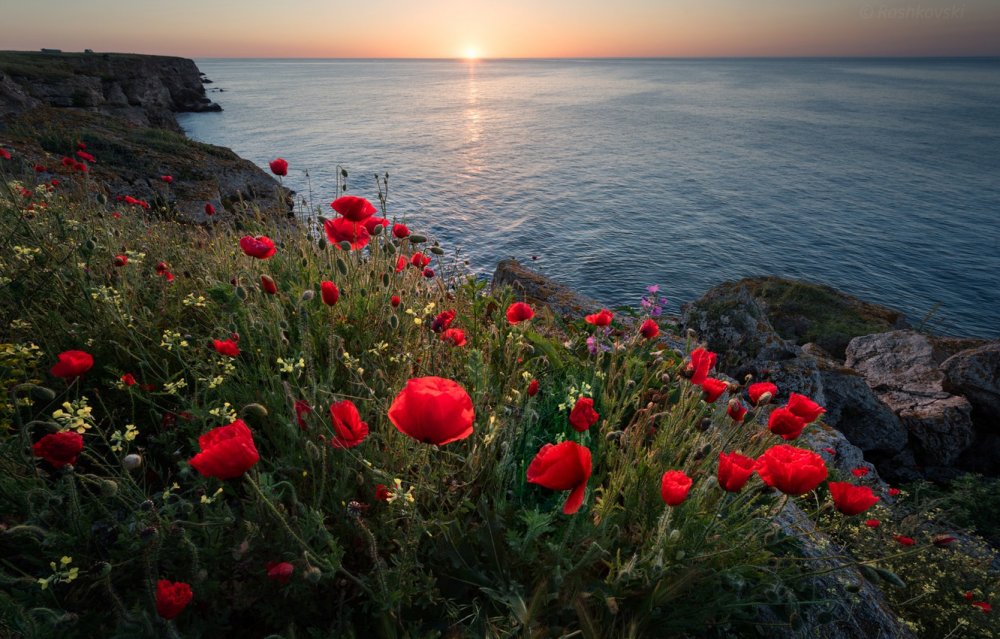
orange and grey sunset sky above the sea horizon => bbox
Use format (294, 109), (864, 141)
(0, 0), (1000, 58)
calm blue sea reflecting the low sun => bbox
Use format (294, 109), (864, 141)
(180, 59), (1000, 337)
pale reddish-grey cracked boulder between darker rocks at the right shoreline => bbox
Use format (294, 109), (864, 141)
(846, 331), (973, 466)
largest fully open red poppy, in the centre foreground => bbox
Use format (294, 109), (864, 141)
(389, 377), (476, 446)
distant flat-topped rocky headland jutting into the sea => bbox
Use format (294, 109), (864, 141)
(0, 52), (222, 132)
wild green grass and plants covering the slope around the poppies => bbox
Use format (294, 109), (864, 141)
(0, 152), (996, 638)
